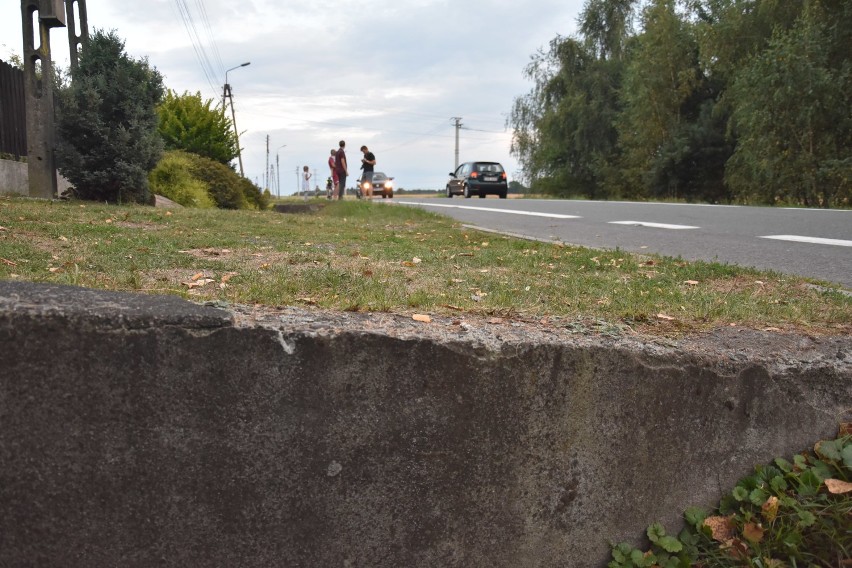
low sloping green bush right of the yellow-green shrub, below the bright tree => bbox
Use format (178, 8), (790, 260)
(183, 153), (271, 209)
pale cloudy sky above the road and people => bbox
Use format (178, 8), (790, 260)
(0, 0), (584, 195)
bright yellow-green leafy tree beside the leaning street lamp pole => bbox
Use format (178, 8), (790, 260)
(157, 91), (237, 165)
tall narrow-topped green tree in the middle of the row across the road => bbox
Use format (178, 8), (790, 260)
(618, 0), (727, 199)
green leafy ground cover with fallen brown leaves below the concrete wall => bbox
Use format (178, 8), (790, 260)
(608, 424), (852, 568)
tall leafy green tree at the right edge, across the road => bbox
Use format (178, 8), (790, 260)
(727, 2), (852, 207)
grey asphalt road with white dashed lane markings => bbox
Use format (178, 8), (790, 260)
(394, 197), (852, 289)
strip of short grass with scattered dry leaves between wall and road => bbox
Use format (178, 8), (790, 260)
(0, 197), (852, 333)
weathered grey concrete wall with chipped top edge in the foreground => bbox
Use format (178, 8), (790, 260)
(0, 282), (852, 567)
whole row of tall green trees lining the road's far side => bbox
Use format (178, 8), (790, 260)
(507, 0), (852, 207)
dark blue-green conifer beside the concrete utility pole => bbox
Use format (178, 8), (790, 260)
(57, 30), (163, 203)
